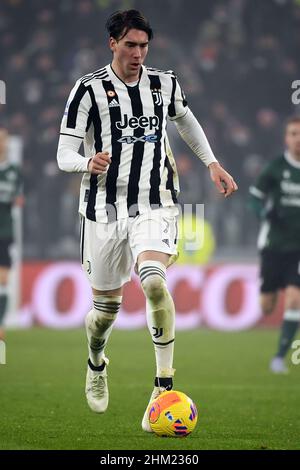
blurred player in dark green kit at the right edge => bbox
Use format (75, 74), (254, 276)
(250, 116), (300, 373)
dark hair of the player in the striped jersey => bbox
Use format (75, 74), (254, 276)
(106, 10), (153, 41)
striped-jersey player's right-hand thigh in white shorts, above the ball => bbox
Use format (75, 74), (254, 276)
(129, 208), (178, 266)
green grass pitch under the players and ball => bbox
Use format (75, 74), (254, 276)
(0, 328), (300, 450)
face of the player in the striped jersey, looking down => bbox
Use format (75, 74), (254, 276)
(110, 29), (149, 81)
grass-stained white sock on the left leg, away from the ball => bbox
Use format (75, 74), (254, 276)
(85, 295), (122, 367)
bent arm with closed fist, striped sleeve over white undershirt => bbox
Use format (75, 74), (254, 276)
(57, 80), (110, 175)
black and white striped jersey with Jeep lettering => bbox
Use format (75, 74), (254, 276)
(61, 65), (188, 222)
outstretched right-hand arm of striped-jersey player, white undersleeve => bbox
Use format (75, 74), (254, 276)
(169, 75), (238, 197)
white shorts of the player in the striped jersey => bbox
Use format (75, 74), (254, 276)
(80, 207), (178, 290)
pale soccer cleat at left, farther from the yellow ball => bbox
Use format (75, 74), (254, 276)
(85, 357), (109, 413)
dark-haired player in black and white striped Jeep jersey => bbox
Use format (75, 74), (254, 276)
(57, 10), (237, 432)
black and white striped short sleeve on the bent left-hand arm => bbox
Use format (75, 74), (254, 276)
(60, 80), (92, 139)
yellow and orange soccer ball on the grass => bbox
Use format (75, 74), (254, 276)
(148, 390), (198, 437)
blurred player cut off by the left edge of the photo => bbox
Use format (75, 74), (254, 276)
(0, 126), (23, 340)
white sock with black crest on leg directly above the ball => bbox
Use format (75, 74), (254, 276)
(139, 261), (175, 377)
